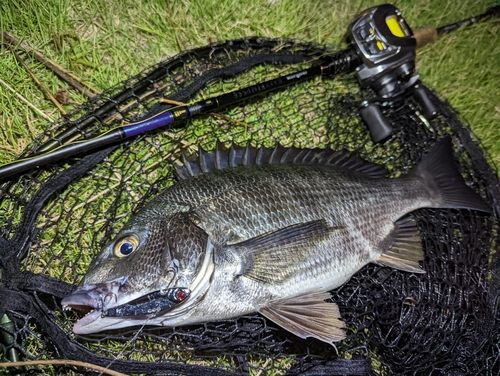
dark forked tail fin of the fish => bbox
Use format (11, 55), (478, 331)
(411, 137), (492, 212)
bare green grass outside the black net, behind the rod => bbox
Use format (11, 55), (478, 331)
(0, 0), (500, 166)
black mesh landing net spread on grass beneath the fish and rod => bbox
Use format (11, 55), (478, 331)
(0, 38), (500, 375)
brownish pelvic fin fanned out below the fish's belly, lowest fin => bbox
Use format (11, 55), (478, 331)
(259, 292), (345, 344)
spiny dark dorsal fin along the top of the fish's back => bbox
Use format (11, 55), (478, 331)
(176, 142), (387, 179)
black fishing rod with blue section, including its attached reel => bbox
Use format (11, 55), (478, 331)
(0, 4), (500, 180)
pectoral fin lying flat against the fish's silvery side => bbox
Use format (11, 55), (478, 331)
(232, 220), (332, 284)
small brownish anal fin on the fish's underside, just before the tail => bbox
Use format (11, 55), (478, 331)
(375, 218), (425, 273)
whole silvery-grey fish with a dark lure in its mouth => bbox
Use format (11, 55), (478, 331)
(61, 137), (491, 346)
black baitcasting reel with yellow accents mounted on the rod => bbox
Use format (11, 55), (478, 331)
(348, 4), (437, 142)
